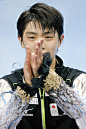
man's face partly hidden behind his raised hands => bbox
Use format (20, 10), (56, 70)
(20, 21), (61, 59)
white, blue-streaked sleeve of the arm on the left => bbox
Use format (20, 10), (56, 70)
(0, 79), (31, 129)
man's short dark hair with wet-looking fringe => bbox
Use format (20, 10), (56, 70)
(17, 3), (63, 38)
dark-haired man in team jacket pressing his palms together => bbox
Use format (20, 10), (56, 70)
(0, 3), (86, 129)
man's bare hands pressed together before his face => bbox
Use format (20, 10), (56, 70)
(23, 40), (43, 85)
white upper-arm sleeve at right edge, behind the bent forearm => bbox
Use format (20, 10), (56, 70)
(73, 73), (86, 129)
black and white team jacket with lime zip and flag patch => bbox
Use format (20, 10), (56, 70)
(0, 56), (86, 129)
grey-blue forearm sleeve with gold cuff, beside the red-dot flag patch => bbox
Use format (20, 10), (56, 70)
(43, 69), (86, 119)
